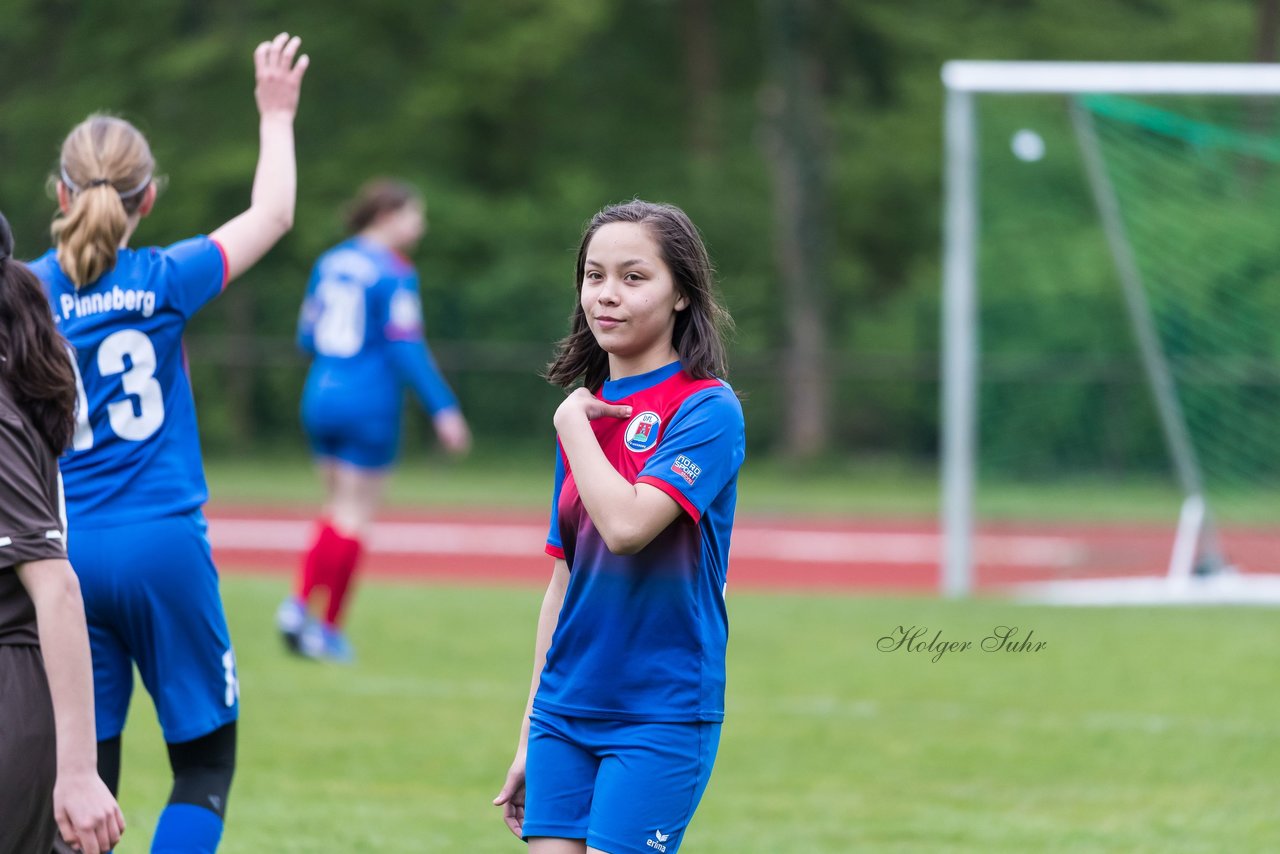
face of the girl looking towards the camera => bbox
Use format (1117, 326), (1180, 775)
(581, 223), (689, 379)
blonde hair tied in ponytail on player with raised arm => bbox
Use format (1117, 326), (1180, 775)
(52, 114), (155, 288)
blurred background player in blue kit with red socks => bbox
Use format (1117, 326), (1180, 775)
(276, 179), (471, 662)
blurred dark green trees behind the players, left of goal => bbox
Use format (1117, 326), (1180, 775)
(0, 0), (1274, 468)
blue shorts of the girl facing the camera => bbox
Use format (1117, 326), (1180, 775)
(524, 711), (721, 854)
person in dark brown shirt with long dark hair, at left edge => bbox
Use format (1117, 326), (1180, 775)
(0, 214), (124, 854)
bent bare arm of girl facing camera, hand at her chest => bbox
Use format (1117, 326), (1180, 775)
(554, 388), (684, 554)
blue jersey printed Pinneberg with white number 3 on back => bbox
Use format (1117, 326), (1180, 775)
(31, 237), (227, 528)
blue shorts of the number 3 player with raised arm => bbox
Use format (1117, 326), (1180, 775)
(67, 510), (239, 743)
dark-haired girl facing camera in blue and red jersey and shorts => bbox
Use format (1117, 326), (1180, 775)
(494, 201), (745, 854)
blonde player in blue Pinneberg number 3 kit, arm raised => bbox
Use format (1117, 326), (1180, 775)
(32, 33), (307, 853)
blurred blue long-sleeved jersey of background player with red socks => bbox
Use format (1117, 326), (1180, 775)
(298, 237), (458, 421)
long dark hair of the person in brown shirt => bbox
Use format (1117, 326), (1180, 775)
(0, 214), (76, 456)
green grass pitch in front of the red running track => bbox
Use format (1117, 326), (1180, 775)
(107, 574), (1280, 854)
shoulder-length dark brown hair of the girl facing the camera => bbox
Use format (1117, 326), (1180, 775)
(544, 198), (733, 392)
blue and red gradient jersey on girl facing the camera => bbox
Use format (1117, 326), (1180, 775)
(534, 362), (746, 722)
